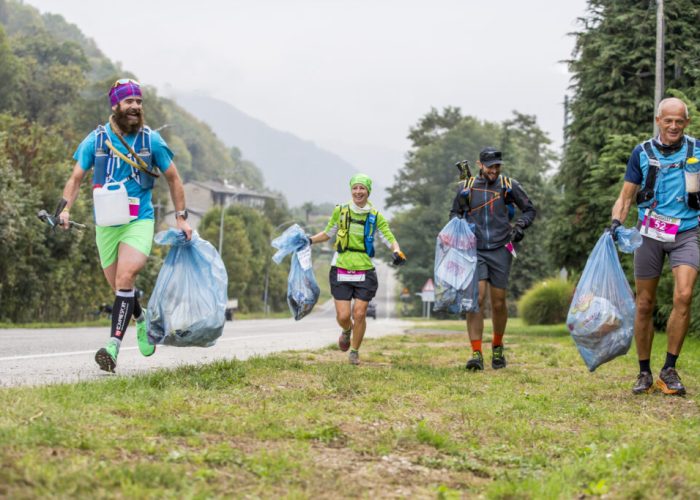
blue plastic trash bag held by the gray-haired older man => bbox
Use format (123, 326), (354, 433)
(566, 232), (635, 371)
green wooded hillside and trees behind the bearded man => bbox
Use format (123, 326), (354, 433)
(0, 0), (288, 323)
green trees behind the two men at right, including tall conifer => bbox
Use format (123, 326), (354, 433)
(388, 0), (700, 334)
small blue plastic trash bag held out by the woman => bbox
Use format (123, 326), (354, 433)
(272, 224), (321, 321)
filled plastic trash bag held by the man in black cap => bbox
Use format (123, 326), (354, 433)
(433, 218), (479, 314)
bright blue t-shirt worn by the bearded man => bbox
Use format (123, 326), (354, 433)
(73, 123), (175, 219)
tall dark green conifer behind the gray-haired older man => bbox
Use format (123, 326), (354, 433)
(550, 0), (700, 271)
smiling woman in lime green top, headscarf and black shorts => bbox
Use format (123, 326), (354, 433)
(309, 174), (406, 365)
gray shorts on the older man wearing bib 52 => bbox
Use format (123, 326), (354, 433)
(634, 228), (700, 280)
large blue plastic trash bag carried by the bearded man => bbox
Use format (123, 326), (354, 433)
(147, 229), (228, 347)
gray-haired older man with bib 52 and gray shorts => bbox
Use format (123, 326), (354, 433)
(610, 98), (700, 395)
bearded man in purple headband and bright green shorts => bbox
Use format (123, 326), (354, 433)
(59, 78), (192, 372)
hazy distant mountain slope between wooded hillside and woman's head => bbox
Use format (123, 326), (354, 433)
(170, 92), (372, 206)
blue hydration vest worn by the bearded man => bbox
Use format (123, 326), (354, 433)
(92, 125), (155, 189)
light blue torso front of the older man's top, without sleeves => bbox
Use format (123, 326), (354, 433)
(638, 136), (700, 231)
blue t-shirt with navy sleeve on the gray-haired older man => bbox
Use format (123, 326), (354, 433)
(625, 136), (700, 231)
